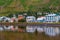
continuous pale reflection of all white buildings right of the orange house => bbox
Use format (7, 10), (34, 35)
(26, 26), (60, 36)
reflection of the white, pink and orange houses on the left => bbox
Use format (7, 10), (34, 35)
(0, 25), (25, 32)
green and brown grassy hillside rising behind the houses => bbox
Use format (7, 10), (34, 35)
(0, 0), (60, 13)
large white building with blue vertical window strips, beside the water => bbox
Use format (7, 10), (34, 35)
(45, 14), (60, 23)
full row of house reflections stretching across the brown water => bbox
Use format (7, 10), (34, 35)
(0, 25), (60, 36)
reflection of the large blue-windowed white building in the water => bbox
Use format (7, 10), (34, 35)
(44, 27), (60, 36)
